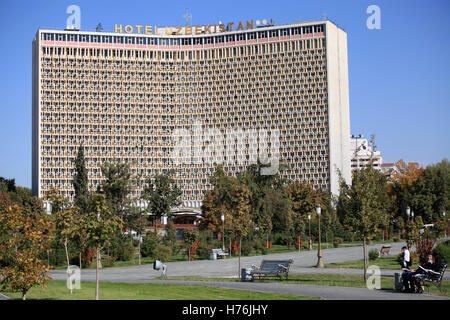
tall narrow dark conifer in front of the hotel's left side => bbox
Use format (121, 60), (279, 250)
(72, 145), (89, 213)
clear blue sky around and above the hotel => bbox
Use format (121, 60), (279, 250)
(0, 0), (450, 187)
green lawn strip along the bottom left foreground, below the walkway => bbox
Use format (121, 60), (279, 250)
(1, 280), (318, 300)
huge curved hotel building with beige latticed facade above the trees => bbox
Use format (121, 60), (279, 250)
(33, 21), (350, 207)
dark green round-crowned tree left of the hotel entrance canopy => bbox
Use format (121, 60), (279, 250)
(144, 171), (182, 228)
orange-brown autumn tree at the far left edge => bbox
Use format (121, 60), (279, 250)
(0, 193), (53, 300)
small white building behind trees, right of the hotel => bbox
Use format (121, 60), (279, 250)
(350, 136), (383, 171)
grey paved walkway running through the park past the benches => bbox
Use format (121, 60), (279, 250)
(49, 243), (450, 300)
